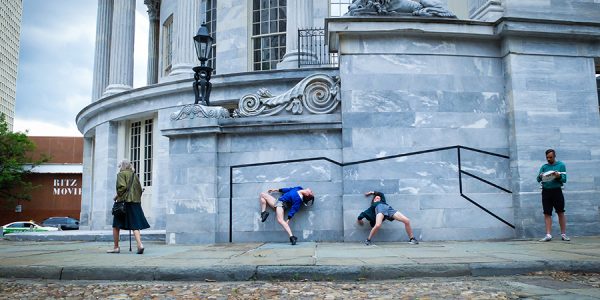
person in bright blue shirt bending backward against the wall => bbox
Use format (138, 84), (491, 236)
(260, 186), (315, 245)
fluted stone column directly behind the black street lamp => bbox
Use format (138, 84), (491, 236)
(170, 0), (201, 77)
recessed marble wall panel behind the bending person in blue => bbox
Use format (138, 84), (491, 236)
(217, 130), (343, 242)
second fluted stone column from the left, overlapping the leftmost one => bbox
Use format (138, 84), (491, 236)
(105, 0), (135, 95)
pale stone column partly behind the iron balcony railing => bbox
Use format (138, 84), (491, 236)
(277, 0), (316, 69)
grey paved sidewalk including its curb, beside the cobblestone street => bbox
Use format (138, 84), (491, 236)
(0, 237), (600, 281)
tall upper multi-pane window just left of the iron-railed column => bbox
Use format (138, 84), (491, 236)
(252, 0), (287, 71)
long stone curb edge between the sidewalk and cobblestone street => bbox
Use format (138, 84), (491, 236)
(0, 261), (600, 281)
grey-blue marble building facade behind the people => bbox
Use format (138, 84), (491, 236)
(77, 0), (600, 244)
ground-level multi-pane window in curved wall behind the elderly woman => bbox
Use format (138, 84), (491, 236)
(129, 119), (154, 187)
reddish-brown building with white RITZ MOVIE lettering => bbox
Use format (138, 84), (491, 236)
(0, 136), (83, 225)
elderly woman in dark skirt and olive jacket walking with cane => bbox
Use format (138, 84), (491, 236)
(107, 159), (150, 254)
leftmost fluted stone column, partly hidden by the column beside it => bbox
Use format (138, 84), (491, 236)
(92, 0), (113, 101)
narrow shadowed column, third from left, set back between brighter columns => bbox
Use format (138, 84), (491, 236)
(144, 0), (160, 85)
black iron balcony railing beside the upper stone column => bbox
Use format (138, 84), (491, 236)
(298, 28), (339, 68)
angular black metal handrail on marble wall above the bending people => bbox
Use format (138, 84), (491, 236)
(229, 145), (515, 243)
